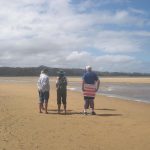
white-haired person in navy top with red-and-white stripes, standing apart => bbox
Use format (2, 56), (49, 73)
(82, 66), (100, 115)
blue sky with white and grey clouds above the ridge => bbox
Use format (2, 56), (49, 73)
(0, 0), (150, 73)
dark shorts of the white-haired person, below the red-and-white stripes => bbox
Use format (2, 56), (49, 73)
(84, 96), (94, 109)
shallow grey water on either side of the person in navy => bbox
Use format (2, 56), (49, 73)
(69, 82), (150, 103)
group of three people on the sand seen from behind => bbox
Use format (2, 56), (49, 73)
(37, 66), (100, 115)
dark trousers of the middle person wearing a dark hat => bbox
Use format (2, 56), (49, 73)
(57, 90), (67, 105)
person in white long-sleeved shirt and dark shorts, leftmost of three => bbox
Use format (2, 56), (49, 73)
(37, 69), (50, 114)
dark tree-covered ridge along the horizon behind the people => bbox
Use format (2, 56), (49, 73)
(0, 66), (150, 77)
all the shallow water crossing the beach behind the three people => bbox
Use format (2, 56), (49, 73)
(0, 77), (150, 103)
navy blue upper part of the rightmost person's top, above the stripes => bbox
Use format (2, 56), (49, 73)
(83, 72), (98, 84)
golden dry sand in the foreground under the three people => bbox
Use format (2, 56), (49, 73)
(0, 78), (150, 150)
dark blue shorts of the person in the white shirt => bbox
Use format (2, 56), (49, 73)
(39, 91), (49, 103)
